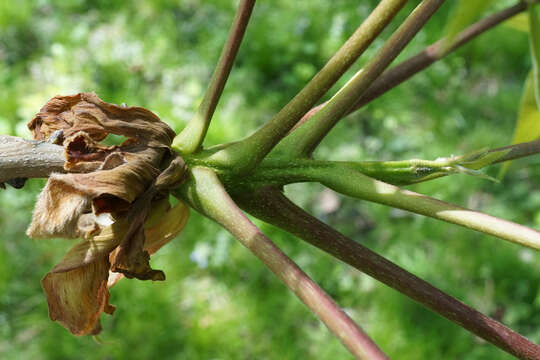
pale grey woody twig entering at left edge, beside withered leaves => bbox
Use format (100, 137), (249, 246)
(0, 135), (64, 183)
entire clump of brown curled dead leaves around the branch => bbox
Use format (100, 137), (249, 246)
(27, 93), (192, 335)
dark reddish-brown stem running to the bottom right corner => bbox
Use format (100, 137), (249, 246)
(234, 187), (540, 360)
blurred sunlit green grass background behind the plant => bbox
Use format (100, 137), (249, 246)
(0, 0), (540, 360)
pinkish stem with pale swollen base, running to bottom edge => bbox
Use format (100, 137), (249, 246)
(176, 167), (387, 359)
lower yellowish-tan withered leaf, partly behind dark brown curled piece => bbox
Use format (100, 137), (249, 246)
(42, 198), (189, 335)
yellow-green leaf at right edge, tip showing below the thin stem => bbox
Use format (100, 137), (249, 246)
(499, 71), (540, 178)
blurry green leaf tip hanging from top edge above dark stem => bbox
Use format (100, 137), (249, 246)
(442, 0), (493, 53)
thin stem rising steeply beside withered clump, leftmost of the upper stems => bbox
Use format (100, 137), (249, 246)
(172, 0), (256, 154)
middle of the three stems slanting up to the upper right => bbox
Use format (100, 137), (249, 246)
(273, 0), (444, 157)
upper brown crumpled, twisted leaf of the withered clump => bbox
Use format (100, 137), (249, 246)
(27, 93), (174, 237)
